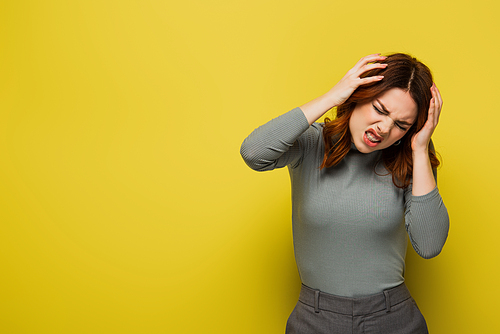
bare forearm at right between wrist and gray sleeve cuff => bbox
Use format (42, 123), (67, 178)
(412, 149), (436, 196)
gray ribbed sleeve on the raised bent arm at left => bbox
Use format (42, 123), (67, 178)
(240, 107), (309, 171)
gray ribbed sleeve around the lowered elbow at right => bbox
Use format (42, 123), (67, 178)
(405, 187), (450, 259)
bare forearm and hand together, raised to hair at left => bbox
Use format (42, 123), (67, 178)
(300, 53), (387, 124)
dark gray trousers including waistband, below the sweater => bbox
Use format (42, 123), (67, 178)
(286, 283), (429, 334)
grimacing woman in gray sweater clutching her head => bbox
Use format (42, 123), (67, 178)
(241, 54), (449, 334)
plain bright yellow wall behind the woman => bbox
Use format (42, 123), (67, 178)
(0, 0), (500, 334)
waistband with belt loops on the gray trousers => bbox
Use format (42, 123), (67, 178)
(299, 283), (411, 316)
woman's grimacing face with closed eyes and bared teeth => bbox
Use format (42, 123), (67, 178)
(349, 88), (417, 153)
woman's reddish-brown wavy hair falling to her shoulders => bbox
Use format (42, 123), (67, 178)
(320, 53), (439, 188)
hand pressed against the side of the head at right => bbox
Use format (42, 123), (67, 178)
(411, 83), (443, 151)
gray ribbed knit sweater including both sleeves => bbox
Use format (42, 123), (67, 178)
(241, 108), (449, 297)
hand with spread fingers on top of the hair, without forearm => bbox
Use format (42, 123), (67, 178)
(327, 53), (387, 107)
